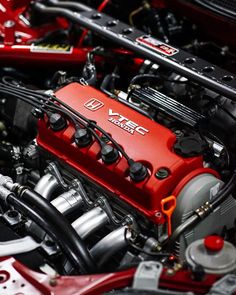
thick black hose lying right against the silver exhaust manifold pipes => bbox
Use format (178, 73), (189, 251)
(17, 189), (97, 273)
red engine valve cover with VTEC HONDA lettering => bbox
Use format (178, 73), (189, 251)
(38, 83), (206, 223)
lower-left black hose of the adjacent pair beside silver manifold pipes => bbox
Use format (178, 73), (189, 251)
(7, 194), (87, 273)
